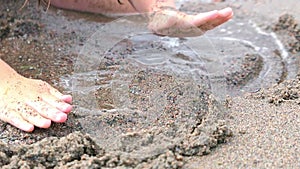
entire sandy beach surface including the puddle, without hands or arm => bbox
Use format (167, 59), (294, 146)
(0, 0), (300, 168)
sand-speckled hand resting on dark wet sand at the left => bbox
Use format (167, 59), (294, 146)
(0, 74), (72, 132)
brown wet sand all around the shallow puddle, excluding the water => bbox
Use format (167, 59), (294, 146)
(0, 1), (300, 168)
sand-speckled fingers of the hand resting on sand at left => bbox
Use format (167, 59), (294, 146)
(0, 97), (72, 132)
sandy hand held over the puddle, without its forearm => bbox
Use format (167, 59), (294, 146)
(148, 7), (233, 37)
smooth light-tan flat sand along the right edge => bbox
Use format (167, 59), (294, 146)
(185, 1), (300, 168)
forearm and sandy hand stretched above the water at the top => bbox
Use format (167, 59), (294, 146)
(51, 0), (233, 37)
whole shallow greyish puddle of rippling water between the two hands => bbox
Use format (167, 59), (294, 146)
(61, 13), (298, 111)
